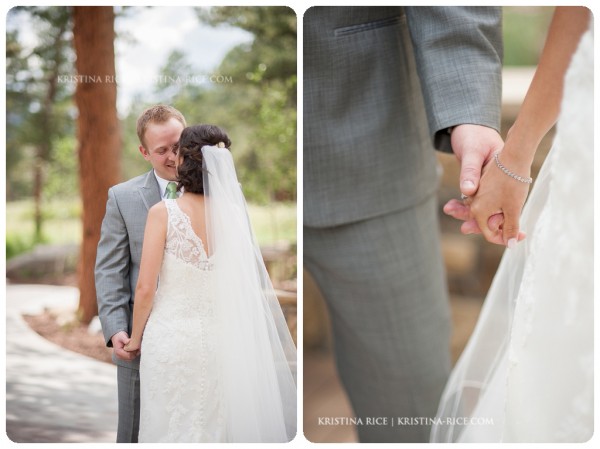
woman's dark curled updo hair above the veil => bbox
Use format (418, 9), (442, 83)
(177, 125), (231, 194)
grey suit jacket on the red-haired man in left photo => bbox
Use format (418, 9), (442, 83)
(96, 170), (161, 369)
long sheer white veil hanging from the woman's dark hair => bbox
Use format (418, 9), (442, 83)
(202, 146), (296, 443)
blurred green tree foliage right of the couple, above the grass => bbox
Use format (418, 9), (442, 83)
(198, 6), (297, 204)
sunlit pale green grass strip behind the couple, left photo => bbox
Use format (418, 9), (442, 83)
(6, 200), (296, 258)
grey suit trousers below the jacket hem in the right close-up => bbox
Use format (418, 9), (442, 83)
(304, 195), (450, 442)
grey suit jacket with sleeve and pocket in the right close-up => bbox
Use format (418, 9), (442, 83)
(304, 6), (502, 227)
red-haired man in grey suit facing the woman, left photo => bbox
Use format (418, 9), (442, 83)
(95, 105), (185, 443)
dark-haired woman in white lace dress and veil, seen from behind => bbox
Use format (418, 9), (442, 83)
(125, 125), (296, 443)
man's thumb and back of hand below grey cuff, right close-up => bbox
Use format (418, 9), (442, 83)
(450, 124), (504, 196)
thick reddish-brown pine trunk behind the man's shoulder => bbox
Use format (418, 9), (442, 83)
(73, 6), (121, 323)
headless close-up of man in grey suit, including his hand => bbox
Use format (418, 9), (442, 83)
(304, 7), (502, 442)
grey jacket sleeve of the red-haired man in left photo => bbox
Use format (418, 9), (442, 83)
(95, 188), (132, 346)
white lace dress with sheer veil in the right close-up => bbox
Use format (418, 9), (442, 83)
(431, 22), (594, 442)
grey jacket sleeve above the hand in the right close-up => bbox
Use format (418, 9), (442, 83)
(405, 6), (503, 151)
